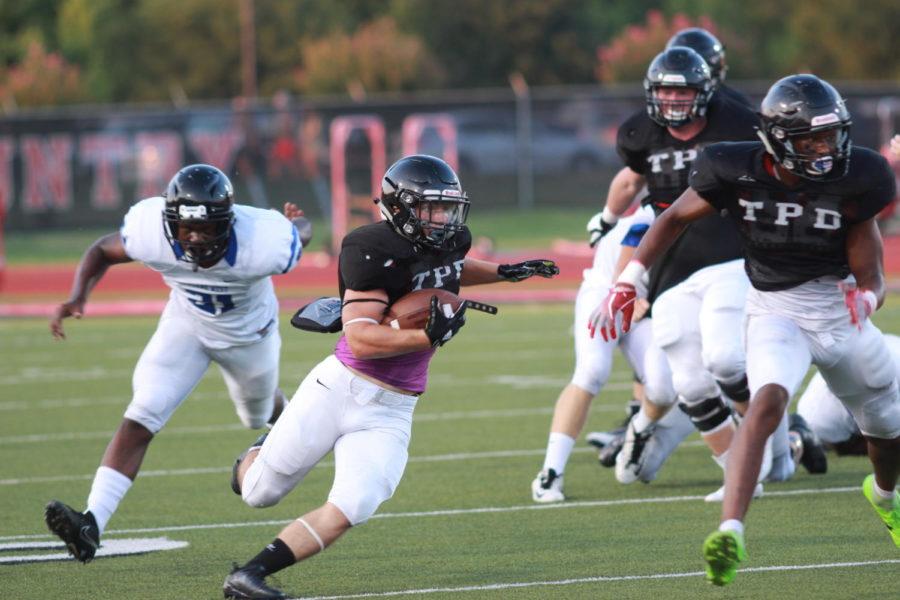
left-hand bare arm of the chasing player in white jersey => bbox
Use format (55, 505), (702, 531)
(50, 232), (131, 340)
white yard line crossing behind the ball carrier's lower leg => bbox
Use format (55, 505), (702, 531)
(0, 486), (859, 543)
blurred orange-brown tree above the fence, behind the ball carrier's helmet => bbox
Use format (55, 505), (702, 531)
(297, 17), (443, 93)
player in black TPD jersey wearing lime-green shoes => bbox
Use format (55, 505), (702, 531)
(601, 75), (900, 585)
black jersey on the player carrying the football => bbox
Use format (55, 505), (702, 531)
(338, 221), (472, 303)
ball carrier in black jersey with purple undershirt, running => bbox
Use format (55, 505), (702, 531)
(224, 155), (559, 598)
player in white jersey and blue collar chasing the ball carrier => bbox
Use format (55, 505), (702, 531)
(45, 165), (312, 563)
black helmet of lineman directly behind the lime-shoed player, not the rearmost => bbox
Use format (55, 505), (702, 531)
(644, 46), (715, 127)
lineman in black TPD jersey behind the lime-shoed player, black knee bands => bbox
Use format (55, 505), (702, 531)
(591, 46), (776, 494)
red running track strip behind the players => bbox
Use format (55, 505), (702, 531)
(0, 236), (900, 317)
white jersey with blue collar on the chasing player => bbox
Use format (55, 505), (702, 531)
(121, 197), (303, 348)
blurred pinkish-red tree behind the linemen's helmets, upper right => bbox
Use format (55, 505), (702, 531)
(596, 10), (718, 83)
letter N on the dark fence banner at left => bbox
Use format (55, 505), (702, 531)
(22, 134), (74, 212)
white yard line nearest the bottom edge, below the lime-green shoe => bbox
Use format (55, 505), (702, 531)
(297, 559), (900, 600)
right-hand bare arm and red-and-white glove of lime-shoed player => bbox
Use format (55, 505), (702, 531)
(842, 218), (885, 327)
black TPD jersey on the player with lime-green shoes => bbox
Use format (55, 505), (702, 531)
(691, 142), (896, 291)
